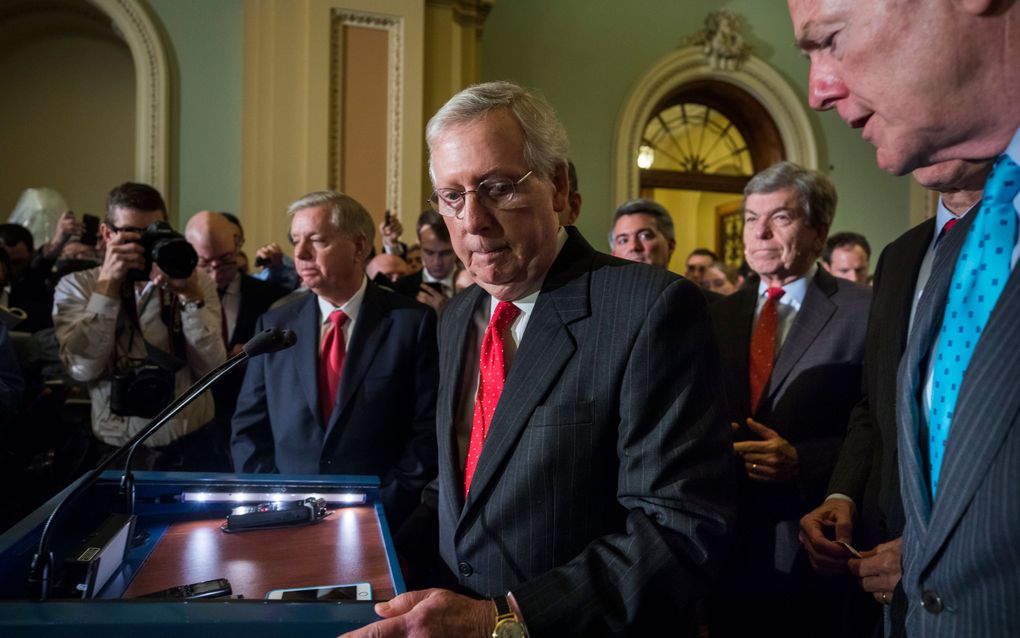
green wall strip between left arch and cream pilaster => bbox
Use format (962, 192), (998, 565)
(149, 0), (244, 228)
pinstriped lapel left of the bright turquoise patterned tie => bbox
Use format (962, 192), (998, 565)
(897, 210), (974, 575)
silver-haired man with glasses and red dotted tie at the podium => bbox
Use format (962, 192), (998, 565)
(342, 83), (731, 637)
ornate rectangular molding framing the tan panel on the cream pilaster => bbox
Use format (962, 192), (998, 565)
(328, 9), (404, 214)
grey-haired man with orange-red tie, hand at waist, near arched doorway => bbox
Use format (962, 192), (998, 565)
(710, 162), (871, 636)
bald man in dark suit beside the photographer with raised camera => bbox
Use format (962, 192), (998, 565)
(185, 210), (287, 465)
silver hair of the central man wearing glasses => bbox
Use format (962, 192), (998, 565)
(425, 82), (570, 183)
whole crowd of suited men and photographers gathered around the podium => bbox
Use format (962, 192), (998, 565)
(0, 0), (1020, 638)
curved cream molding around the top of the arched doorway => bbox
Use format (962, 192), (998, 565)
(610, 46), (818, 206)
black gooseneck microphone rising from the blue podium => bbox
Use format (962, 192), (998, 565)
(29, 328), (298, 600)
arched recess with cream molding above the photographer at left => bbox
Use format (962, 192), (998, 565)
(0, 0), (170, 214)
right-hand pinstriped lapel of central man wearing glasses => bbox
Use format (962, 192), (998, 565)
(458, 228), (594, 529)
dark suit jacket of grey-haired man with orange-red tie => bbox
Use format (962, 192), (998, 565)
(711, 266), (871, 589)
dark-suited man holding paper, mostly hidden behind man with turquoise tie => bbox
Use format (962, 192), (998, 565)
(801, 160), (990, 635)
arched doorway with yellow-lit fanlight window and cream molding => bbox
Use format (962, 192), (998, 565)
(613, 46), (818, 273)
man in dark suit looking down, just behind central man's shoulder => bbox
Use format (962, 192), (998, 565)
(394, 208), (458, 312)
